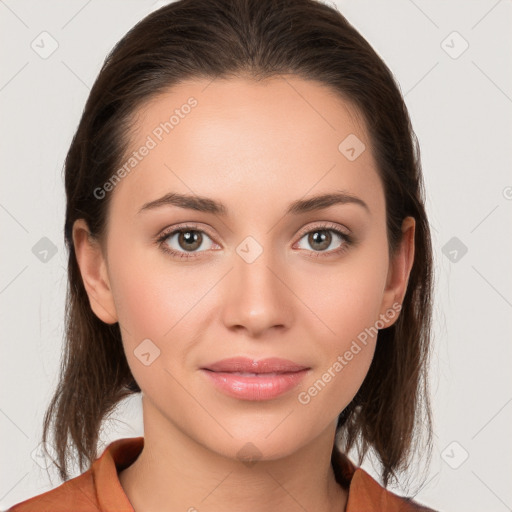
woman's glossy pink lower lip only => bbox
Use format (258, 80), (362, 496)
(201, 369), (308, 400)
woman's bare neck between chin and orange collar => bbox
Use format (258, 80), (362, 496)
(119, 402), (348, 512)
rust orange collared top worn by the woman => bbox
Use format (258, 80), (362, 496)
(6, 437), (434, 512)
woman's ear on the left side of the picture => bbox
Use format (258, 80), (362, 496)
(73, 219), (118, 324)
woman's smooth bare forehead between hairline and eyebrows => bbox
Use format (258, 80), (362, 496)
(108, 75), (382, 218)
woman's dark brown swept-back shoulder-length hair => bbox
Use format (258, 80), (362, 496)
(43, 0), (433, 492)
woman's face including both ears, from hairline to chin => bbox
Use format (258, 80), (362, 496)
(74, 76), (414, 459)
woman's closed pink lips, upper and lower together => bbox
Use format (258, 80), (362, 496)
(201, 357), (310, 401)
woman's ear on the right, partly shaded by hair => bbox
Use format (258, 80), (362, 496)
(380, 217), (416, 327)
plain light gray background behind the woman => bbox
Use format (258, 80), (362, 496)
(0, 0), (512, 512)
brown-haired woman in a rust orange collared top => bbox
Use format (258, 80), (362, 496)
(7, 0), (432, 512)
